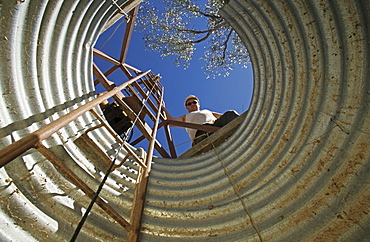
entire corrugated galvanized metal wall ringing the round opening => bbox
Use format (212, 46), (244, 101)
(0, 0), (370, 241)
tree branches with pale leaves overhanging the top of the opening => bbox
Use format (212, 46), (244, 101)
(137, 0), (249, 77)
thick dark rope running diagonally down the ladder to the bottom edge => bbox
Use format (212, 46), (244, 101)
(70, 75), (160, 242)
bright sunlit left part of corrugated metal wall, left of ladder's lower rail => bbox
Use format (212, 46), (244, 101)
(0, 0), (137, 241)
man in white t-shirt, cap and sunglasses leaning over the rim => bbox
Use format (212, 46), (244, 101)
(169, 95), (239, 145)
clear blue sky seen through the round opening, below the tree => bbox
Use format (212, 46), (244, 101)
(94, 6), (253, 155)
